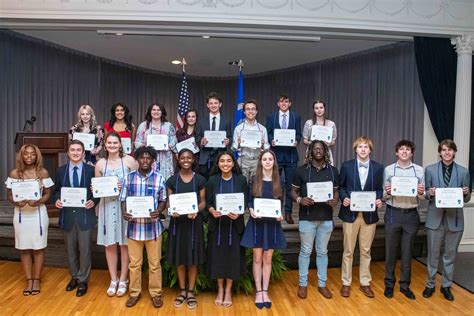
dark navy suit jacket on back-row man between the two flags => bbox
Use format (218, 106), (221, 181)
(196, 113), (232, 165)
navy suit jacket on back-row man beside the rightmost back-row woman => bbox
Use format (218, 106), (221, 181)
(266, 111), (301, 164)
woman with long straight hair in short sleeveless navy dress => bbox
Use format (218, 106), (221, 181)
(240, 149), (286, 309)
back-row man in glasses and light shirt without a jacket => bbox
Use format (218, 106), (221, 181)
(232, 100), (270, 181)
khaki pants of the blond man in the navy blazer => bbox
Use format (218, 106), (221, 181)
(341, 213), (377, 286)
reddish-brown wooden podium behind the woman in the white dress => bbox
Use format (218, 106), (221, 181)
(15, 132), (69, 216)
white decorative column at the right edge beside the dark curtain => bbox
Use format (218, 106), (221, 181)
(451, 34), (474, 168)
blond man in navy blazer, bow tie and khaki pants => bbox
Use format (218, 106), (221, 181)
(339, 136), (383, 298)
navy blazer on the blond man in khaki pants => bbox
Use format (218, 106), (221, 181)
(339, 159), (384, 224)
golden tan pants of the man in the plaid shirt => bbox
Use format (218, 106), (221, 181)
(128, 235), (162, 297)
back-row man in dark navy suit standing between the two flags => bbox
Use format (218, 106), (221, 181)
(196, 92), (232, 179)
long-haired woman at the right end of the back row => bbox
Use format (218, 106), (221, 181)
(303, 100), (337, 165)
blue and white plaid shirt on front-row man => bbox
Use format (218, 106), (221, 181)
(120, 170), (166, 241)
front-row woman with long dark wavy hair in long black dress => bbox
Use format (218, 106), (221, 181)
(206, 151), (248, 307)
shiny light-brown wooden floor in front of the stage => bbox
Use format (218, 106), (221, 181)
(0, 261), (474, 316)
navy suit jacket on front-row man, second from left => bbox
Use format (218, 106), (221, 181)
(54, 164), (100, 231)
